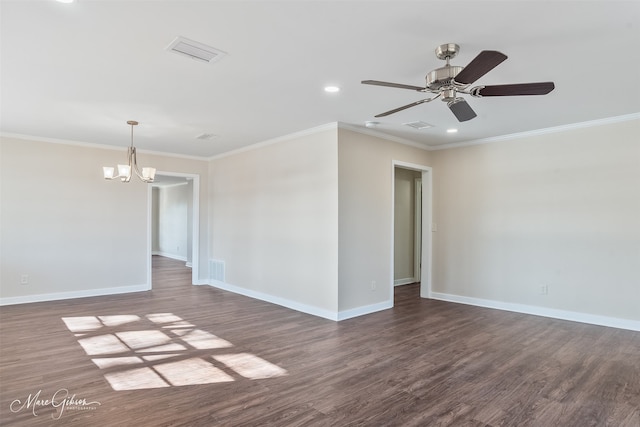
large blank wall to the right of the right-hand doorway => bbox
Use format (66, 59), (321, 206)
(433, 120), (640, 320)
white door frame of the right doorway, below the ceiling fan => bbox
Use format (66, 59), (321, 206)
(389, 160), (433, 301)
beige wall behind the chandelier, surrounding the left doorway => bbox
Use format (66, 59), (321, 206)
(0, 137), (207, 303)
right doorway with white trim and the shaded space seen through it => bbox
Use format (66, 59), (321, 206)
(391, 161), (432, 298)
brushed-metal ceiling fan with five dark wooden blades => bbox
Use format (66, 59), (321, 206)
(362, 43), (555, 122)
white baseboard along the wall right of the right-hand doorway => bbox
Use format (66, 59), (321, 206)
(429, 292), (640, 331)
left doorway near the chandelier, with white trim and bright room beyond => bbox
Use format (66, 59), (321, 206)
(147, 172), (200, 286)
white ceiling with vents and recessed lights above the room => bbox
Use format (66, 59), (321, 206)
(0, 0), (640, 157)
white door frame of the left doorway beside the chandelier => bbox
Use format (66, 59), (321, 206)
(147, 171), (200, 289)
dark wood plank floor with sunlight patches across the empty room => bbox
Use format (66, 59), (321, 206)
(0, 257), (640, 427)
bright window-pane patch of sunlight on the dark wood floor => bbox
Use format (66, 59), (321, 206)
(62, 313), (287, 390)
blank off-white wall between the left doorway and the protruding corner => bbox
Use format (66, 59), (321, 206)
(209, 127), (338, 318)
